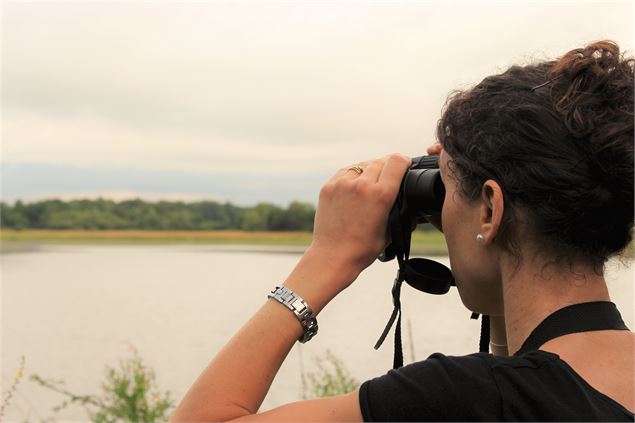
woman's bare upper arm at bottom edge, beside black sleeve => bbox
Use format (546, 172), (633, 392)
(232, 390), (363, 422)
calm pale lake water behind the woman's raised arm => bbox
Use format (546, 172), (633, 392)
(1, 245), (633, 421)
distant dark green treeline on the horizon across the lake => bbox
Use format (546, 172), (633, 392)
(0, 199), (315, 231)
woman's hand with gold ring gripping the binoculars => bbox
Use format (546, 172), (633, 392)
(310, 154), (412, 289)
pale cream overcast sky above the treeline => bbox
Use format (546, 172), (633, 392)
(1, 1), (633, 205)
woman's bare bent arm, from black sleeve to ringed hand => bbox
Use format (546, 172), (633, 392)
(171, 155), (410, 422)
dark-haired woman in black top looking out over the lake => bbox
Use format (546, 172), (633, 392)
(173, 41), (635, 421)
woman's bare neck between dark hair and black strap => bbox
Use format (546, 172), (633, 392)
(502, 253), (610, 354)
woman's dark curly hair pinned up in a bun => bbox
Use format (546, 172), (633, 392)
(437, 41), (634, 266)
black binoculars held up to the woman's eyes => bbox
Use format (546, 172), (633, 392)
(379, 156), (445, 261)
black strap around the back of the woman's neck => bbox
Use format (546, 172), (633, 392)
(514, 301), (629, 355)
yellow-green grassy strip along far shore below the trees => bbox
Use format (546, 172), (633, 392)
(0, 229), (447, 255)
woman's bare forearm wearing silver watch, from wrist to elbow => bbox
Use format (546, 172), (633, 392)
(172, 248), (357, 421)
